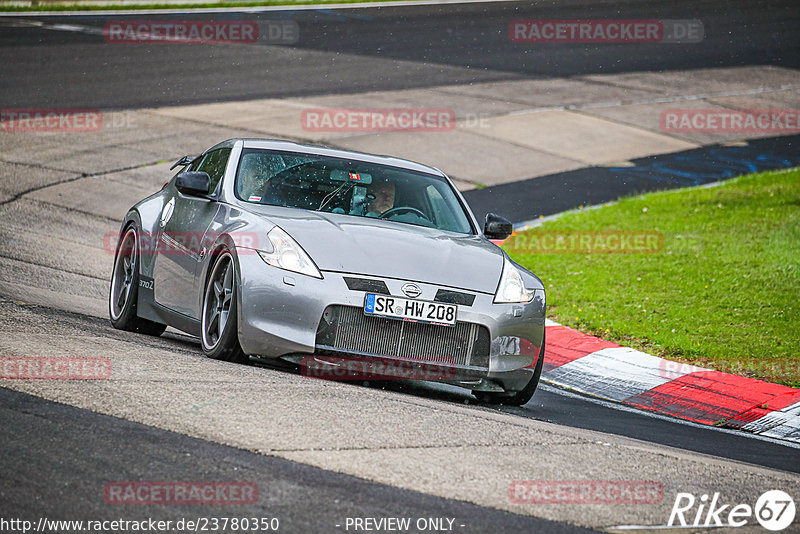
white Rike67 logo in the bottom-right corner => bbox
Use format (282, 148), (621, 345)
(667, 490), (796, 532)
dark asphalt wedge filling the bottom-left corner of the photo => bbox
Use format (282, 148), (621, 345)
(0, 389), (592, 534)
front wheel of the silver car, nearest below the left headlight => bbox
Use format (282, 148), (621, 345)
(200, 250), (247, 363)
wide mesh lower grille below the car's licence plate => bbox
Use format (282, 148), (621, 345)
(316, 306), (489, 369)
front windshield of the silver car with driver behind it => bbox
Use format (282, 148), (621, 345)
(236, 149), (472, 234)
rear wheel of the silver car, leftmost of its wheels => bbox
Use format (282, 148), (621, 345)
(108, 224), (167, 336)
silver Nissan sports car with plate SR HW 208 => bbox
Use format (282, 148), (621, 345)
(109, 139), (545, 405)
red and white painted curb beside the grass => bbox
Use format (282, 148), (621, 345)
(542, 320), (800, 443)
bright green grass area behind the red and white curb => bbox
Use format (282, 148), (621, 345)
(504, 169), (800, 387)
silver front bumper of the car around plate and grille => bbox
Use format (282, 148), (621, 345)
(233, 250), (545, 389)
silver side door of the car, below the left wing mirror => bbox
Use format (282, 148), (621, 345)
(153, 148), (231, 319)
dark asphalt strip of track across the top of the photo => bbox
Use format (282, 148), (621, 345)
(0, 0), (800, 109)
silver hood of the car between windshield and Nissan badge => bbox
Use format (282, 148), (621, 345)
(252, 206), (503, 294)
